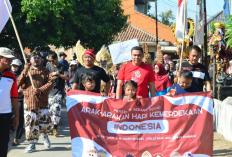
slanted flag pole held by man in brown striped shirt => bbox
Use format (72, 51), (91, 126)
(4, 0), (35, 89)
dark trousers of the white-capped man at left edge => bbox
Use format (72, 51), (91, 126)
(0, 113), (12, 157)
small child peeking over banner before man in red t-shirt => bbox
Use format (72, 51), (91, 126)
(123, 80), (142, 101)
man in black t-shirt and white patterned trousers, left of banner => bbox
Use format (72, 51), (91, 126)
(46, 52), (69, 136)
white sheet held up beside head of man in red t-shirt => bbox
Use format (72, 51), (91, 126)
(109, 39), (139, 64)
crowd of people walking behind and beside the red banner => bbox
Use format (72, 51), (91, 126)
(0, 45), (211, 156)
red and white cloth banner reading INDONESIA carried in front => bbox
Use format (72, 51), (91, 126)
(67, 90), (214, 157)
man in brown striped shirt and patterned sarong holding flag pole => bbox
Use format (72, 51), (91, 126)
(17, 52), (53, 153)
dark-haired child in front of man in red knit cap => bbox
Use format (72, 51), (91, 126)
(78, 72), (96, 92)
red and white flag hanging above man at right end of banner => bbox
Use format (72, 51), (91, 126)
(175, 0), (188, 39)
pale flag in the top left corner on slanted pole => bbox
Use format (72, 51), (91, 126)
(0, 0), (12, 33)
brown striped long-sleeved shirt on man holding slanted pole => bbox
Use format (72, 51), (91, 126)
(17, 67), (53, 111)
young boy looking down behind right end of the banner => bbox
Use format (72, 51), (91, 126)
(167, 70), (199, 95)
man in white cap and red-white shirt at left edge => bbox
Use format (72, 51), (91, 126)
(0, 47), (19, 157)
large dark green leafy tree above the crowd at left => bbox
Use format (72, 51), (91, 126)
(0, 0), (128, 51)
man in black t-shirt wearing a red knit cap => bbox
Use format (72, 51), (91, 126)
(72, 49), (110, 96)
